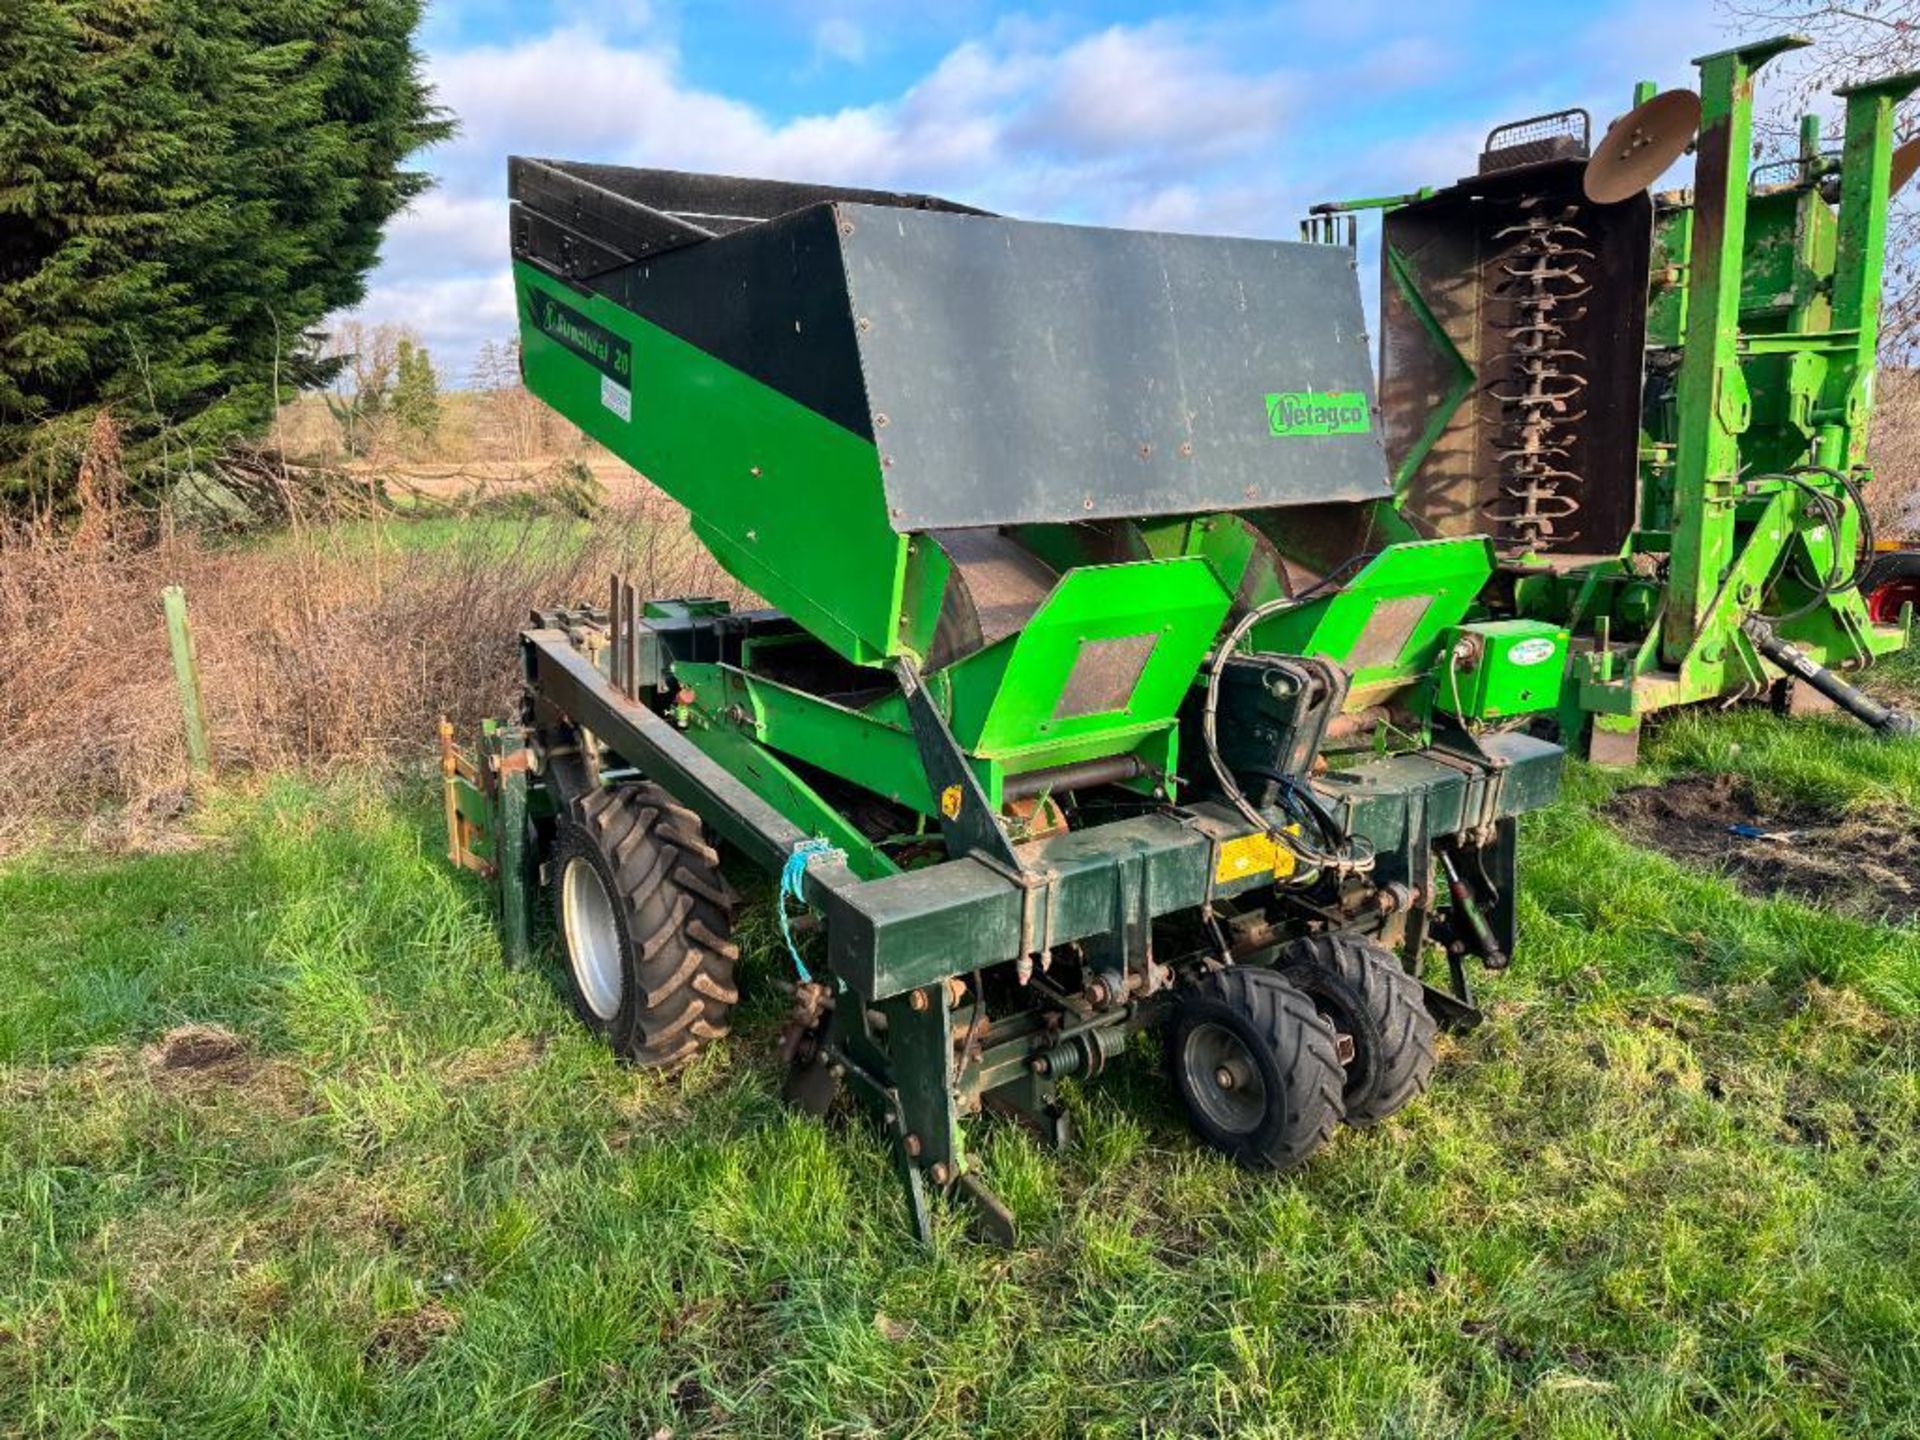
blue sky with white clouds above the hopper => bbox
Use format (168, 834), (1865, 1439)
(357, 0), (1734, 384)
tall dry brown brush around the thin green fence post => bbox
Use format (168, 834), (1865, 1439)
(0, 488), (739, 839)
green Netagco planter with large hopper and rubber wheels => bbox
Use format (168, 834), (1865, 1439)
(444, 159), (1567, 1236)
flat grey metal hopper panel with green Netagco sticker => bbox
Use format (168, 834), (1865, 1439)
(835, 202), (1392, 530)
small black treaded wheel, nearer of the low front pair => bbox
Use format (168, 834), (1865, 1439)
(1167, 966), (1342, 1169)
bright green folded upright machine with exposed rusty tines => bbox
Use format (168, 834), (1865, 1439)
(1302, 36), (1920, 762)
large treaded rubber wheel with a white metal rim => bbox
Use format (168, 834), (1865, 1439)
(549, 781), (739, 1069)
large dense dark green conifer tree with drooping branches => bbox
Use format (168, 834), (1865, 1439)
(0, 0), (451, 501)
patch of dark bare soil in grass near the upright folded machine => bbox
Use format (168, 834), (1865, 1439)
(1607, 776), (1920, 925)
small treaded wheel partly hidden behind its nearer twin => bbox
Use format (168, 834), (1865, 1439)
(1275, 935), (1440, 1125)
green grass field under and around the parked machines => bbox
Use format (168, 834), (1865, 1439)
(0, 712), (1920, 1436)
